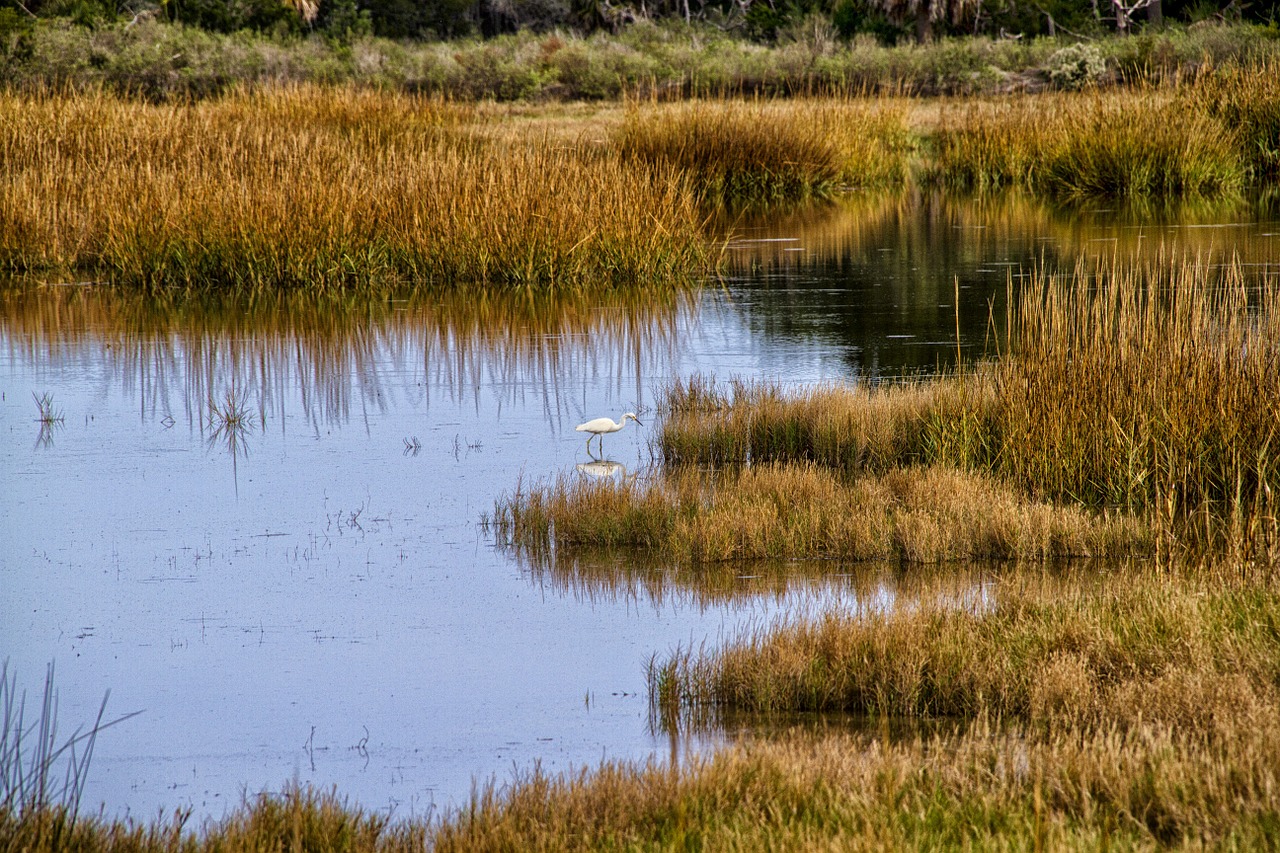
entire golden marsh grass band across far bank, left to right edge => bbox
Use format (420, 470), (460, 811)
(0, 68), (1280, 292)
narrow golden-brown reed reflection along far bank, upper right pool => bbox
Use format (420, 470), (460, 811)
(719, 190), (1276, 274)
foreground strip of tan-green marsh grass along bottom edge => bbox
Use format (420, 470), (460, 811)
(0, 721), (1280, 853)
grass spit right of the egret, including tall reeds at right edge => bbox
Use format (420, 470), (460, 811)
(659, 257), (1280, 560)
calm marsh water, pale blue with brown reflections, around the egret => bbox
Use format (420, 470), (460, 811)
(0, 190), (1280, 817)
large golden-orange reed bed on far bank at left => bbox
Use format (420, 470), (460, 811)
(0, 88), (710, 291)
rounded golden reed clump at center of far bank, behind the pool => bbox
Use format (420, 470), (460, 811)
(616, 100), (908, 204)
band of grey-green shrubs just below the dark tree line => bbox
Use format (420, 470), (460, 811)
(0, 7), (1280, 100)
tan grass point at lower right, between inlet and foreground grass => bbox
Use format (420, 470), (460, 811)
(649, 573), (1280, 727)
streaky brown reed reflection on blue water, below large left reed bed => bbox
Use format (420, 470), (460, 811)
(0, 282), (689, 429)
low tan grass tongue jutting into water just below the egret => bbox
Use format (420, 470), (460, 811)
(494, 465), (1149, 564)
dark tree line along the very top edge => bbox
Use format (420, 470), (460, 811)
(0, 0), (1280, 40)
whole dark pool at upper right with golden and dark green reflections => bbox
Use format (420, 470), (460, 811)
(722, 191), (1280, 383)
